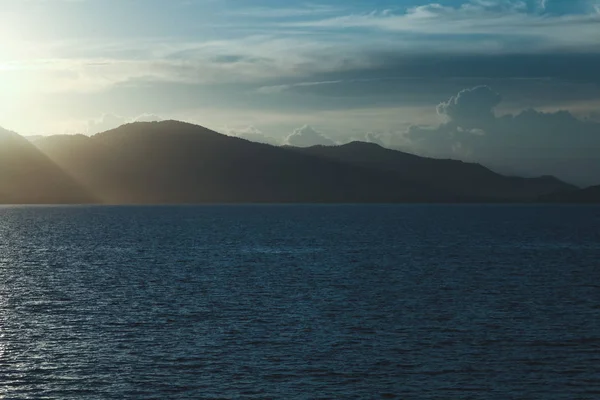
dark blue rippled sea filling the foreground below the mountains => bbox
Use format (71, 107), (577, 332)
(0, 205), (600, 399)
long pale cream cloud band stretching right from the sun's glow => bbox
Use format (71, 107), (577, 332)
(0, 35), (380, 93)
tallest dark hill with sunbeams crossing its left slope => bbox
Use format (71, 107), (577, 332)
(35, 121), (449, 203)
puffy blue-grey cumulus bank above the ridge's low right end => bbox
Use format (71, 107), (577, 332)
(402, 86), (600, 185)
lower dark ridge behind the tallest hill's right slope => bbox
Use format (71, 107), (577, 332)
(298, 142), (575, 201)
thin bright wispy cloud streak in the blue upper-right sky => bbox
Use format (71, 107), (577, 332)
(293, 0), (600, 52)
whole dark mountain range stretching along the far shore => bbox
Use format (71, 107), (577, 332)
(0, 121), (600, 204)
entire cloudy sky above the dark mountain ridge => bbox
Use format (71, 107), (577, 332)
(0, 0), (600, 185)
